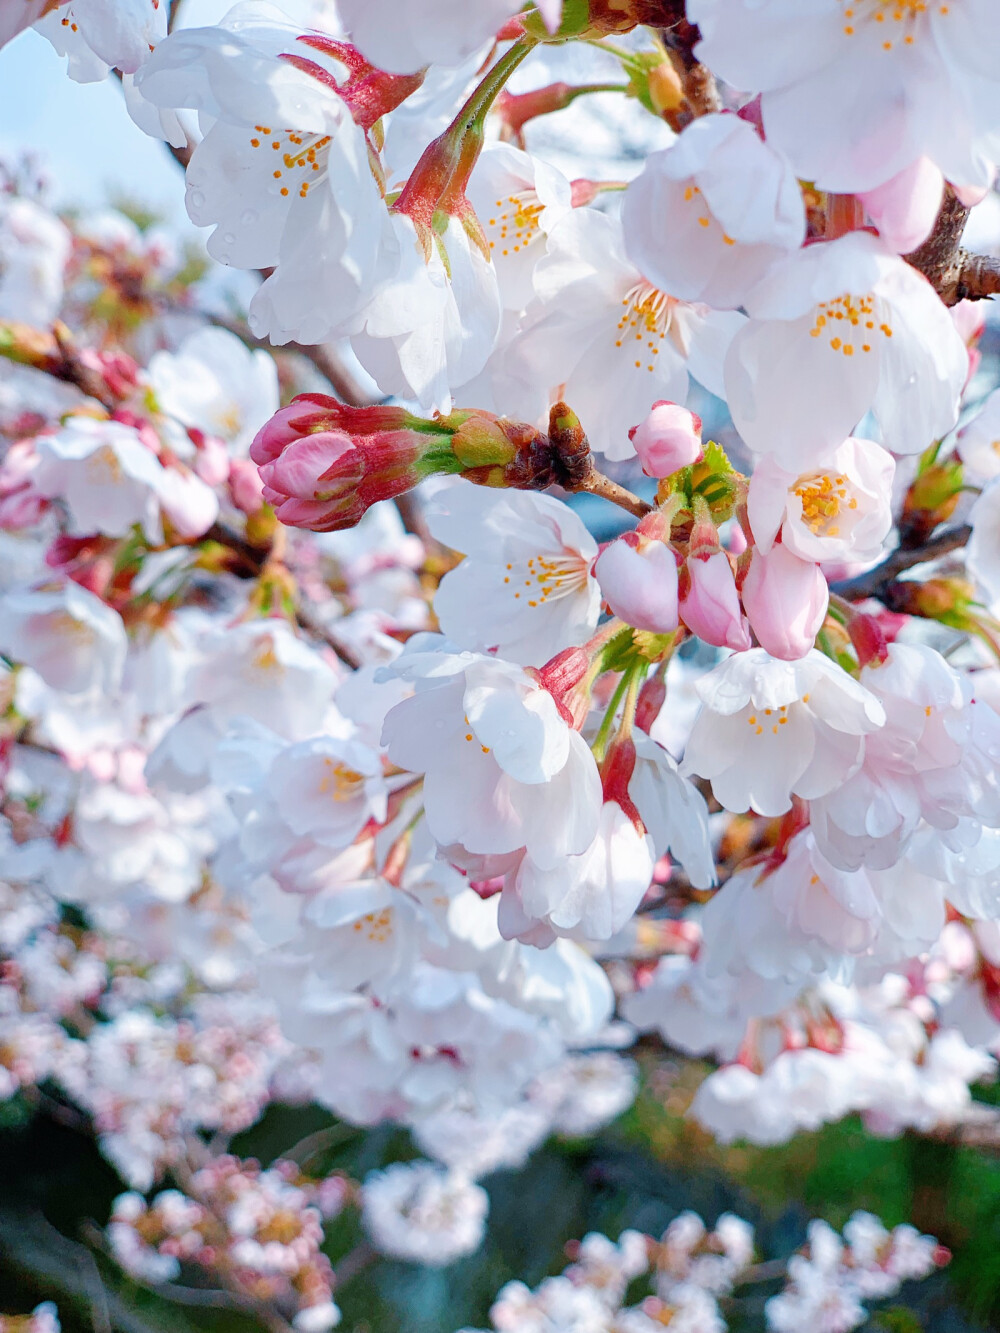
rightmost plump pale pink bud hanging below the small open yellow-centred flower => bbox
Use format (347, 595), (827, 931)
(743, 544), (829, 661)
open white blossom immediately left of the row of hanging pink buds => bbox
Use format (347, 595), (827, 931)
(427, 481), (600, 667)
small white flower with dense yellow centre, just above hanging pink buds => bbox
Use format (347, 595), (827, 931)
(747, 439), (896, 561)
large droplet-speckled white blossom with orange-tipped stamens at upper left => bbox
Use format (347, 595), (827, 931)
(137, 0), (395, 343)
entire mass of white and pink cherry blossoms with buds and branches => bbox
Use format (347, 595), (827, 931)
(0, 0), (1000, 1317)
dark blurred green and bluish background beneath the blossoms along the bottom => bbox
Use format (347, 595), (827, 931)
(0, 1056), (1000, 1333)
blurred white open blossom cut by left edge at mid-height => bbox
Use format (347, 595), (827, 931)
(0, 583), (128, 694)
